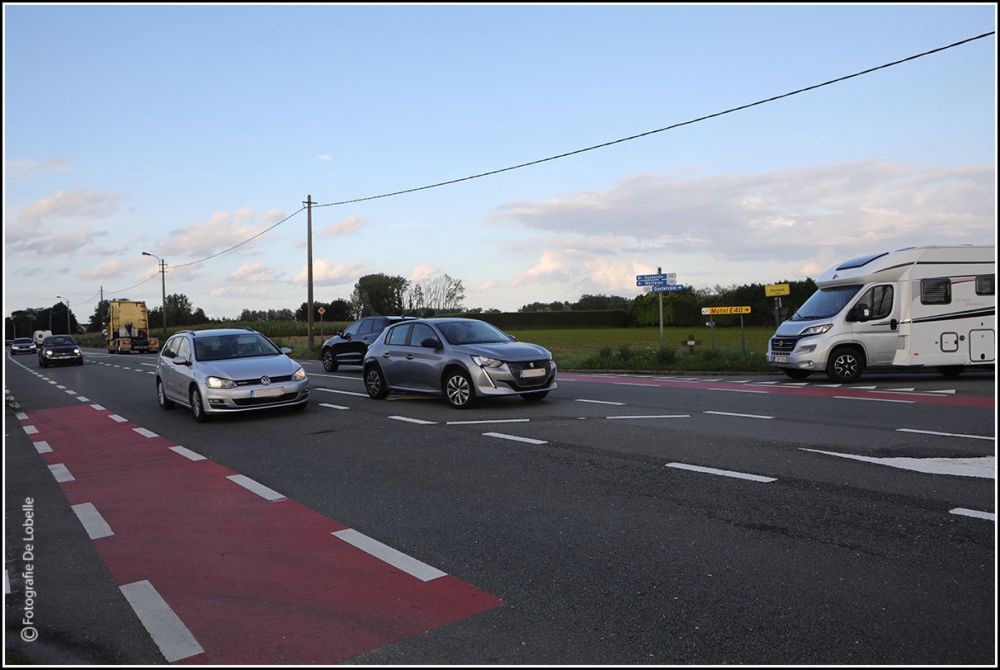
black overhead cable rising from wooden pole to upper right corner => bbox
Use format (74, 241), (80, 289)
(316, 31), (996, 207)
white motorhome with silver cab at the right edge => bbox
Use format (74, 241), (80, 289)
(767, 245), (996, 382)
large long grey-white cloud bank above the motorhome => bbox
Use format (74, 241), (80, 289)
(501, 161), (996, 276)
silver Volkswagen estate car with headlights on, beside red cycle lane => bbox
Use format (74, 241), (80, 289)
(156, 328), (309, 421)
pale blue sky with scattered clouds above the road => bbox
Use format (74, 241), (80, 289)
(3, 3), (997, 321)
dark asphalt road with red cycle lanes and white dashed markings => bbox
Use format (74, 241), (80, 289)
(4, 351), (996, 665)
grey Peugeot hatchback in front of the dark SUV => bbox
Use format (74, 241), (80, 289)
(363, 318), (557, 409)
